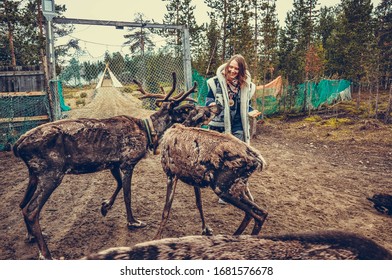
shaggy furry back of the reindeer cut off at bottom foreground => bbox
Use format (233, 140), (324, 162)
(84, 231), (392, 260)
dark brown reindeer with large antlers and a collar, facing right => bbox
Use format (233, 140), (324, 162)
(13, 73), (219, 259)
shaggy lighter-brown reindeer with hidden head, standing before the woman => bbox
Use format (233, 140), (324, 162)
(155, 124), (267, 239)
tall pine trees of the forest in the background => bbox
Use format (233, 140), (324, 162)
(0, 0), (392, 89)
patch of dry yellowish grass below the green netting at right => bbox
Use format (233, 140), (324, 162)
(263, 93), (392, 147)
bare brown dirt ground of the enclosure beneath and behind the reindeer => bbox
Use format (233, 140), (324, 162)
(0, 86), (392, 260)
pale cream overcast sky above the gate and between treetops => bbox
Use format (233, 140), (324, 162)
(55, 0), (380, 57)
